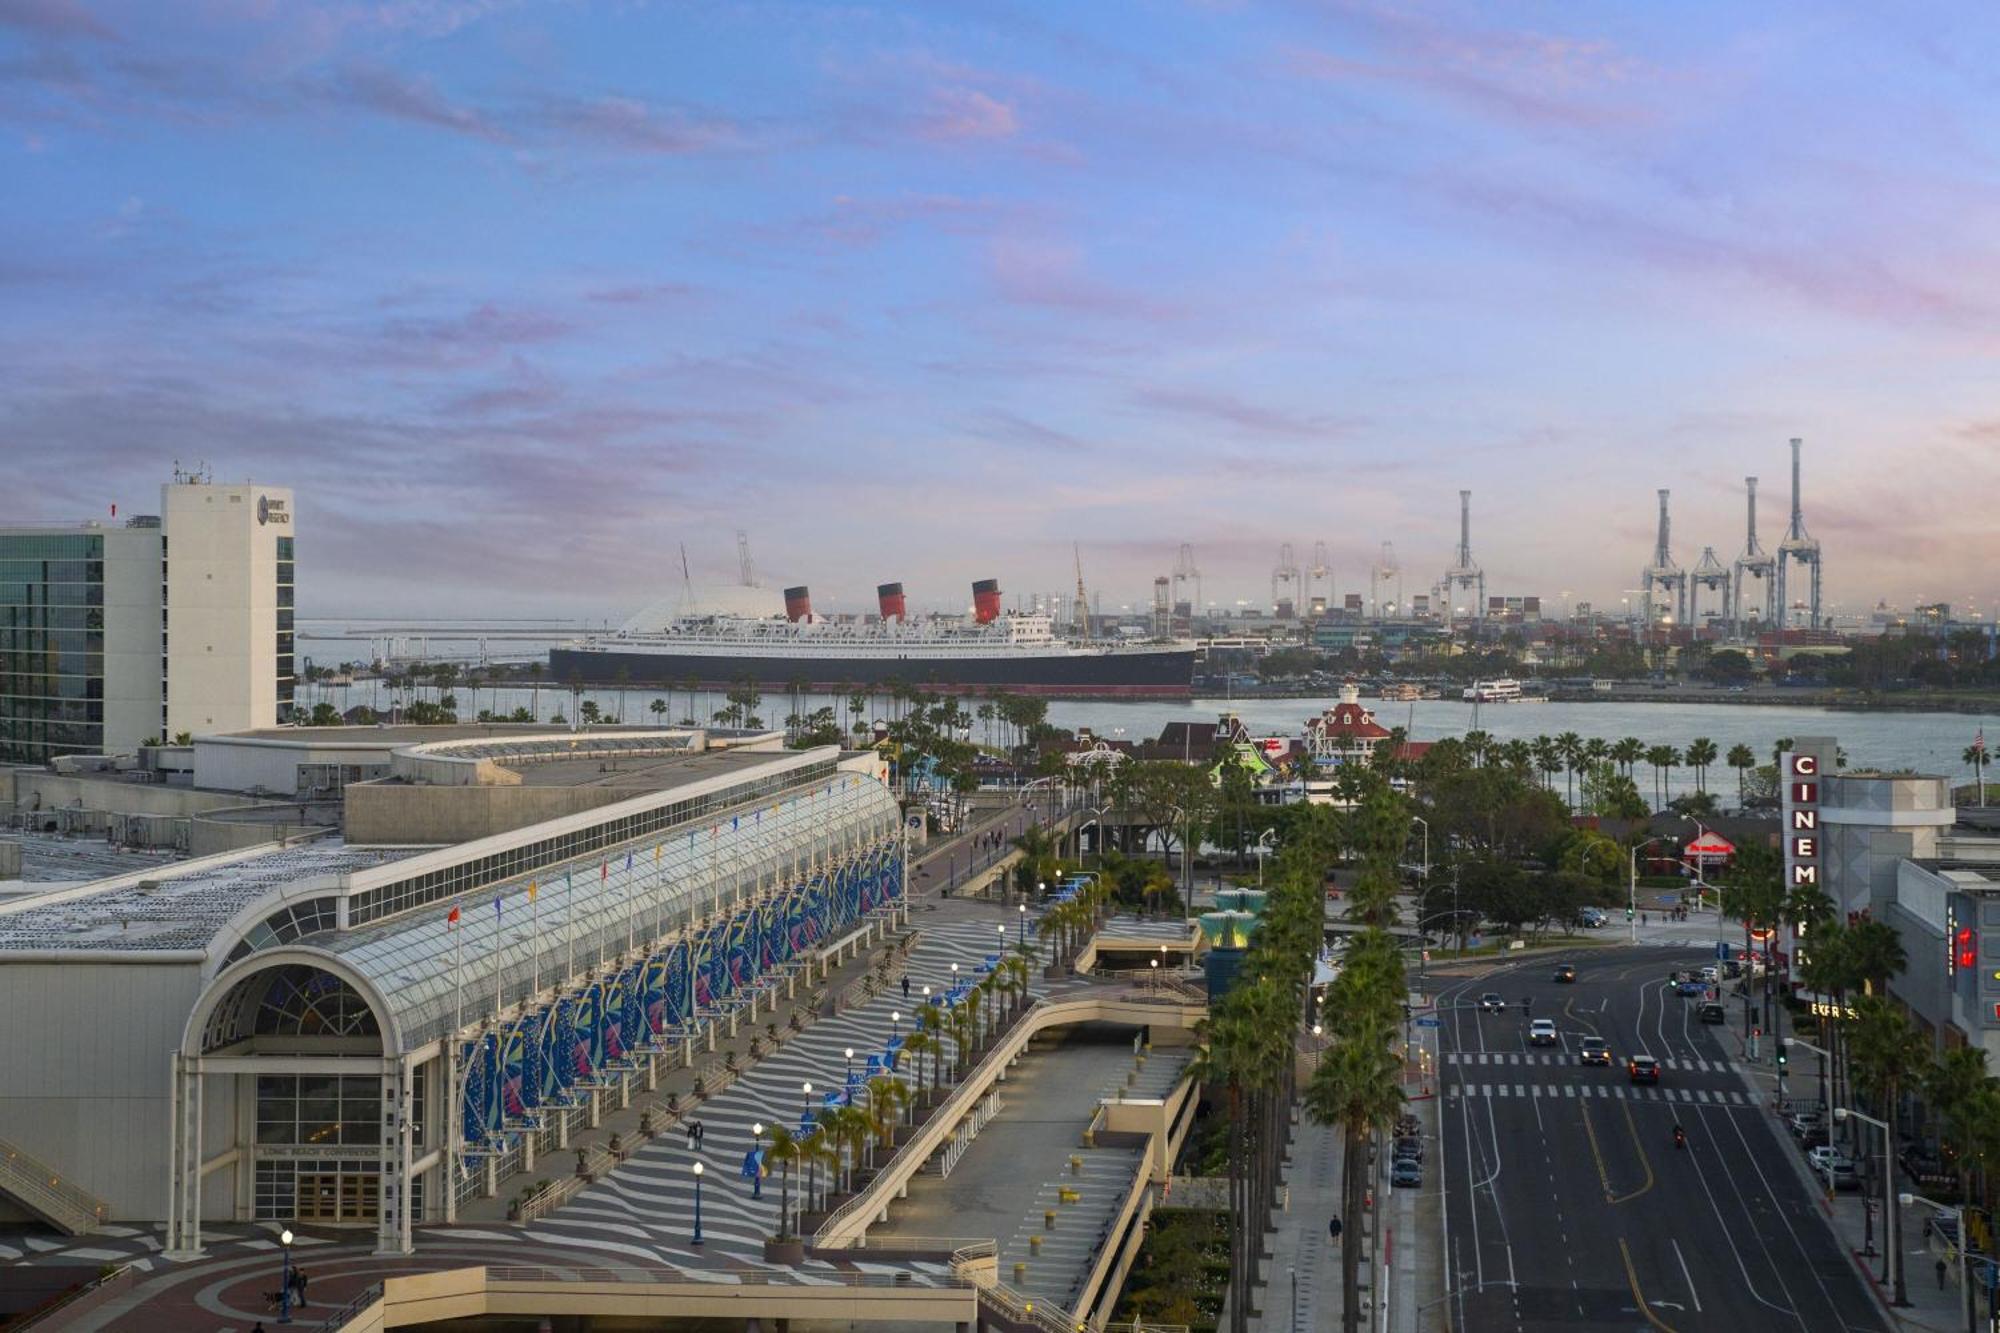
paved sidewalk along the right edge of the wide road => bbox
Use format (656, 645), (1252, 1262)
(1722, 1016), (1986, 1333)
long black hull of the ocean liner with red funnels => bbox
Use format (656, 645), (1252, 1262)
(548, 648), (1194, 699)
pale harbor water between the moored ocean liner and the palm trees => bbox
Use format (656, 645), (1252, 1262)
(300, 681), (2000, 801)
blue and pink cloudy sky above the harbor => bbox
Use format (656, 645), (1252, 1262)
(0, 0), (2000, 618)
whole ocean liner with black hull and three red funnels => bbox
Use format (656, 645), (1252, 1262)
(548, 578), (1196, 699)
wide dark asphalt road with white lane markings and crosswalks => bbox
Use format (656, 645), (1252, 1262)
(1420, 947), (1884, 1333)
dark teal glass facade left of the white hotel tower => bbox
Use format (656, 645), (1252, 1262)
(0, 532), (104, 763)
